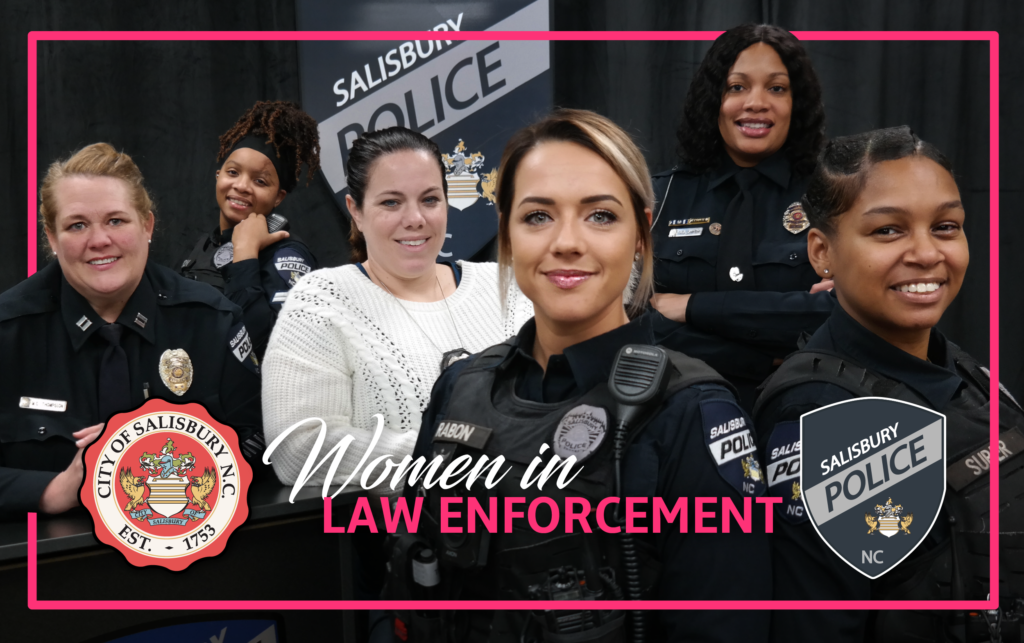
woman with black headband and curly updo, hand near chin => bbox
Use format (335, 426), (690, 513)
(179, 100), (319, 358)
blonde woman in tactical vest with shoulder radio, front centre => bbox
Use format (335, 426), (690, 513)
(388, 110), (769, 642)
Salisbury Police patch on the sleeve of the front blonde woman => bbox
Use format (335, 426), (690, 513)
(700, 399), (765, 496)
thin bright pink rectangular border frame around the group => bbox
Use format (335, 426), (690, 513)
(28, 31), (999, 610)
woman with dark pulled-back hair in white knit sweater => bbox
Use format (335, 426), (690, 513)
(263, 127), (532, 494)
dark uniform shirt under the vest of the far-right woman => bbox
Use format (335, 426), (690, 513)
(755, 306), (1019, 643)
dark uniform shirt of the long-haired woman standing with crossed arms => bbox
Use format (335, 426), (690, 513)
(651, 152), (834, 408)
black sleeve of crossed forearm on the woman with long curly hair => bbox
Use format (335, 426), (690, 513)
(686, 291), (836, 357)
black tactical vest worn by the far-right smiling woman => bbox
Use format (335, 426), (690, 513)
(754, 342), (1024, 642)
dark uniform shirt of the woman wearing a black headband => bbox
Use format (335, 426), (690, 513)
(178, 223), (319, 358)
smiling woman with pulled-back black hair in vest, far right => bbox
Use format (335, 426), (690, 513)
(755, 127), (1024, 643)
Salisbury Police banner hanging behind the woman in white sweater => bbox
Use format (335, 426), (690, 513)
(298, 0), (552, 259)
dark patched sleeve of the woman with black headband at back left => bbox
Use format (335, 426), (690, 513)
(220, 242), (316, 359)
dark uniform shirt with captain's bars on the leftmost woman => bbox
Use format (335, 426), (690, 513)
(0, 261), (261, 519)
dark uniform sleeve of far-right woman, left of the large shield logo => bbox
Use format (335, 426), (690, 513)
(757, 383), (871, 643)
